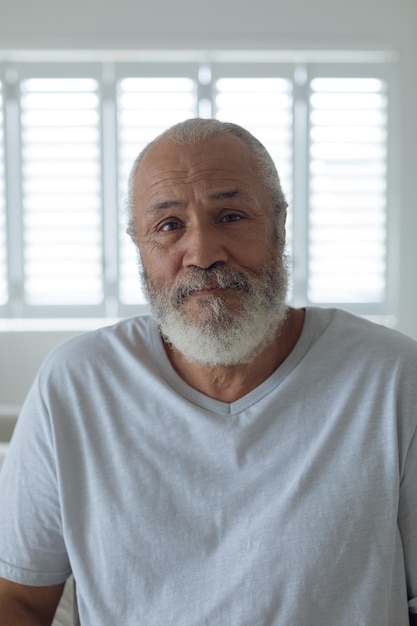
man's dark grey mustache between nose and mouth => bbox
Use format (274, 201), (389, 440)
(171, 267), (253, 305)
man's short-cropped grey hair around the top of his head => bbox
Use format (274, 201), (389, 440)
(127, 118), (288, 244)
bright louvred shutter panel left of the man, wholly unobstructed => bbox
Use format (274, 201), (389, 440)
(21, 78), (103, 305)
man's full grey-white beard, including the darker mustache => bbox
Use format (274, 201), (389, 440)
(142, 255), (287, 367)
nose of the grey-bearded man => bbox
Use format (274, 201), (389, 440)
(182, 223), (228, 269)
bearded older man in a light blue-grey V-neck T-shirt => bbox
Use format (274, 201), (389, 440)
(0, 120), (417, 626)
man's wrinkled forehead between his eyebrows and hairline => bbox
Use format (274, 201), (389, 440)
(134, 135), (265, 206)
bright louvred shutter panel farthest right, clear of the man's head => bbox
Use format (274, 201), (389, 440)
(308, 78), (387, 303)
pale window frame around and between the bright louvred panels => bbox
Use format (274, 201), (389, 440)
(0, 51), (399, 319)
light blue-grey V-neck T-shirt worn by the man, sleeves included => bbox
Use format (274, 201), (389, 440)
(0, 309), (417, 626)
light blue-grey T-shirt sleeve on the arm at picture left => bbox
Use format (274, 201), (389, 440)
(0, 376), (71, 586)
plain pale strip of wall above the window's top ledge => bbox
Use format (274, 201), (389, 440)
(0, 0), (416, 47)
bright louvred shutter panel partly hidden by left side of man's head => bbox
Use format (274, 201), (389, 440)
(118, 77), (197, 304)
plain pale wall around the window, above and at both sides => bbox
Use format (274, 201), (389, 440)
(0, 0), (417, 405)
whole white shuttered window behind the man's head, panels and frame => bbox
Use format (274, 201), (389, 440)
(0, 59), (396, 317)
